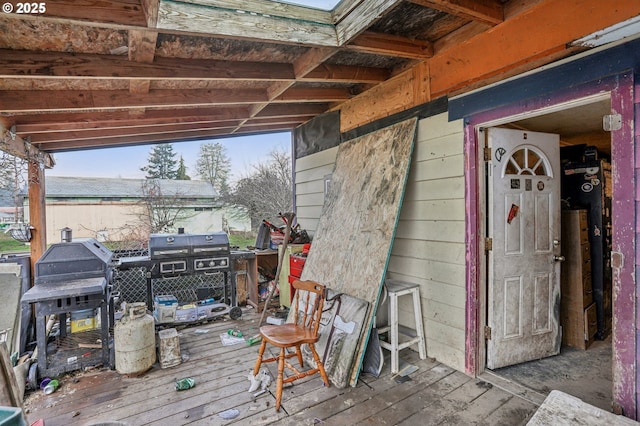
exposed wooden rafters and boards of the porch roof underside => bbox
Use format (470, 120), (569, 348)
(0, 0), (608, 161)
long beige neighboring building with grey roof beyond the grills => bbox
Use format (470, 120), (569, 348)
(25, 176), (249, 244)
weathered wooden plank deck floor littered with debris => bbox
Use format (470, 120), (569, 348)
(24, 312), (537, 426)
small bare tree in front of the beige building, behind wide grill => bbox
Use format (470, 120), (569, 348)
(136, 179), (194, 234)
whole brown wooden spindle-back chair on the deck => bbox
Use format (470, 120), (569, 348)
(253, 280), (329, 411)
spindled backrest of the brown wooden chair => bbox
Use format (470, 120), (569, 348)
(291, 280), (326, 335)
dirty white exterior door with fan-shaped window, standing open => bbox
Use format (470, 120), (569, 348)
(486, 128), (562, 369)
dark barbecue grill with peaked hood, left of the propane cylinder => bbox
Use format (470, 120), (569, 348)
(22, 238), (113, 375)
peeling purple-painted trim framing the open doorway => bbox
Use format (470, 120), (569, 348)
(464, 73), (640, 418)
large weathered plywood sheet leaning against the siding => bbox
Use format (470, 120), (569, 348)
(302, 119), (416, 386)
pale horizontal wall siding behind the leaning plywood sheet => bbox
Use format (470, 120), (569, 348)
(295, 113), (466, 371)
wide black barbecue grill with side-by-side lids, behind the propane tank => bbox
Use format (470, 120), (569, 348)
(117, 232), (242, 319)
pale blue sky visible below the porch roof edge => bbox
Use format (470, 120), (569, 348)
(45, 132), (291, 182)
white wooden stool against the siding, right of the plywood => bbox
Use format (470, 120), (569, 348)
(378, 280), (427, 374)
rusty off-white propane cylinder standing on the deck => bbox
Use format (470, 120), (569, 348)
(113, 302), (156, 374)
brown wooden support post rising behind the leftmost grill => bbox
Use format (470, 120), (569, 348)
(28, 159), (47, 277)
